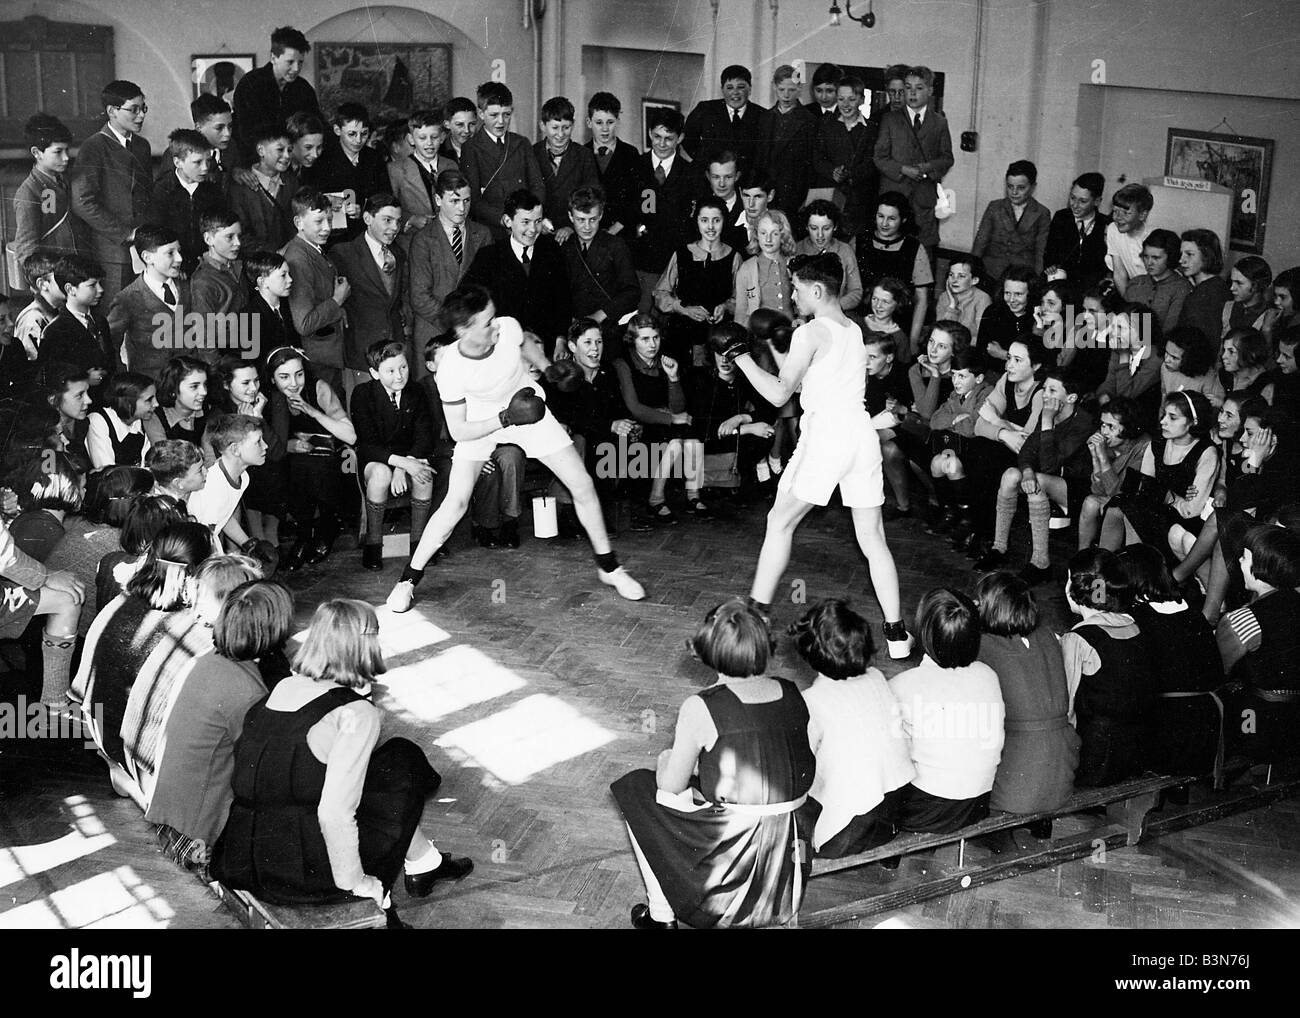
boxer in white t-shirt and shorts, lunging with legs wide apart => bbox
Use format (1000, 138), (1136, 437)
(387, 285), (647, 611)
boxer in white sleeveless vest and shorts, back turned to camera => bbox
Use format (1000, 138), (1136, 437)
(715, 252), (911, 659)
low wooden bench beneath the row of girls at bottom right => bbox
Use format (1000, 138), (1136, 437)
(797, 775), (1300, 928)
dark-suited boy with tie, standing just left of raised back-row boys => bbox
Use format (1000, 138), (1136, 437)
(629, 107), (699, 312)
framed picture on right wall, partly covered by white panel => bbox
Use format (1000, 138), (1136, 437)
(1165, 127), (1273, 255)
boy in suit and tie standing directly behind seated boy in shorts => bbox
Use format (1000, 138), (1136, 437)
(329, 194), (413, 397)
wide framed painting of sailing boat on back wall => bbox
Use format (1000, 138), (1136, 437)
(312, 42), (451, 121)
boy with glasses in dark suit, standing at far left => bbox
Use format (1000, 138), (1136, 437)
(70, 81), (153, 300)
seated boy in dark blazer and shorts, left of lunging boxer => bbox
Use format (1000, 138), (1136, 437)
(351, 339), (434, 571)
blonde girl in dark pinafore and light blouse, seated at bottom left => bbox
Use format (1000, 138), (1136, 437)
(212, 598), (473, 924)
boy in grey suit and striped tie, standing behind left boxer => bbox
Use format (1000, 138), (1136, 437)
(411, 170), (491, 366)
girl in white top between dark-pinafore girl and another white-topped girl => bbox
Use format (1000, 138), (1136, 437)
(790, 599), (917, 858)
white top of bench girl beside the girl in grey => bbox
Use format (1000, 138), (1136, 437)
(889, 654), (1006, 800)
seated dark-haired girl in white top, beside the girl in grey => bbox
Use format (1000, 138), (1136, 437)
(889, 588), (1006, 833)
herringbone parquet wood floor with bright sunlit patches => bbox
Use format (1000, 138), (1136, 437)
(0, 496), (1300, 928)
